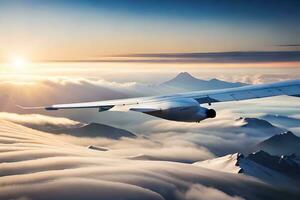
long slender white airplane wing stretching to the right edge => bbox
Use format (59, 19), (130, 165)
(19, 79), (300, 112)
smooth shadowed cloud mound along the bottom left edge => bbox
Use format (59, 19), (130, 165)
(0, 178), (163, 200)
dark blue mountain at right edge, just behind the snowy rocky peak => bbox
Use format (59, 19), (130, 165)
(255, 131), (300, 155)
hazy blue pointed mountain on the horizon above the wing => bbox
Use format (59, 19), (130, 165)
(160, 72), (247, 91)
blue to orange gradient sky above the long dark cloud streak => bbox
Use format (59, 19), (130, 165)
(0, 0), (300, 61)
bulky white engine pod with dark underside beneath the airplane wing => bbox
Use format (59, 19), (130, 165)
(145, 99), (216, 122)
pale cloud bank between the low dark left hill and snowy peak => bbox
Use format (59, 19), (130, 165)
(49, 127), (215, 163)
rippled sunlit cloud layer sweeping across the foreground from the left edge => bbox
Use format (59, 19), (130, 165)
(0, 121), (299, 200)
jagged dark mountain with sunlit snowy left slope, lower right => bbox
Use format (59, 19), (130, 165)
(193, 151), (300, 184)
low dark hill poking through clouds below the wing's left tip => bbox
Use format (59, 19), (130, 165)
(49, 123), (136, 139)
